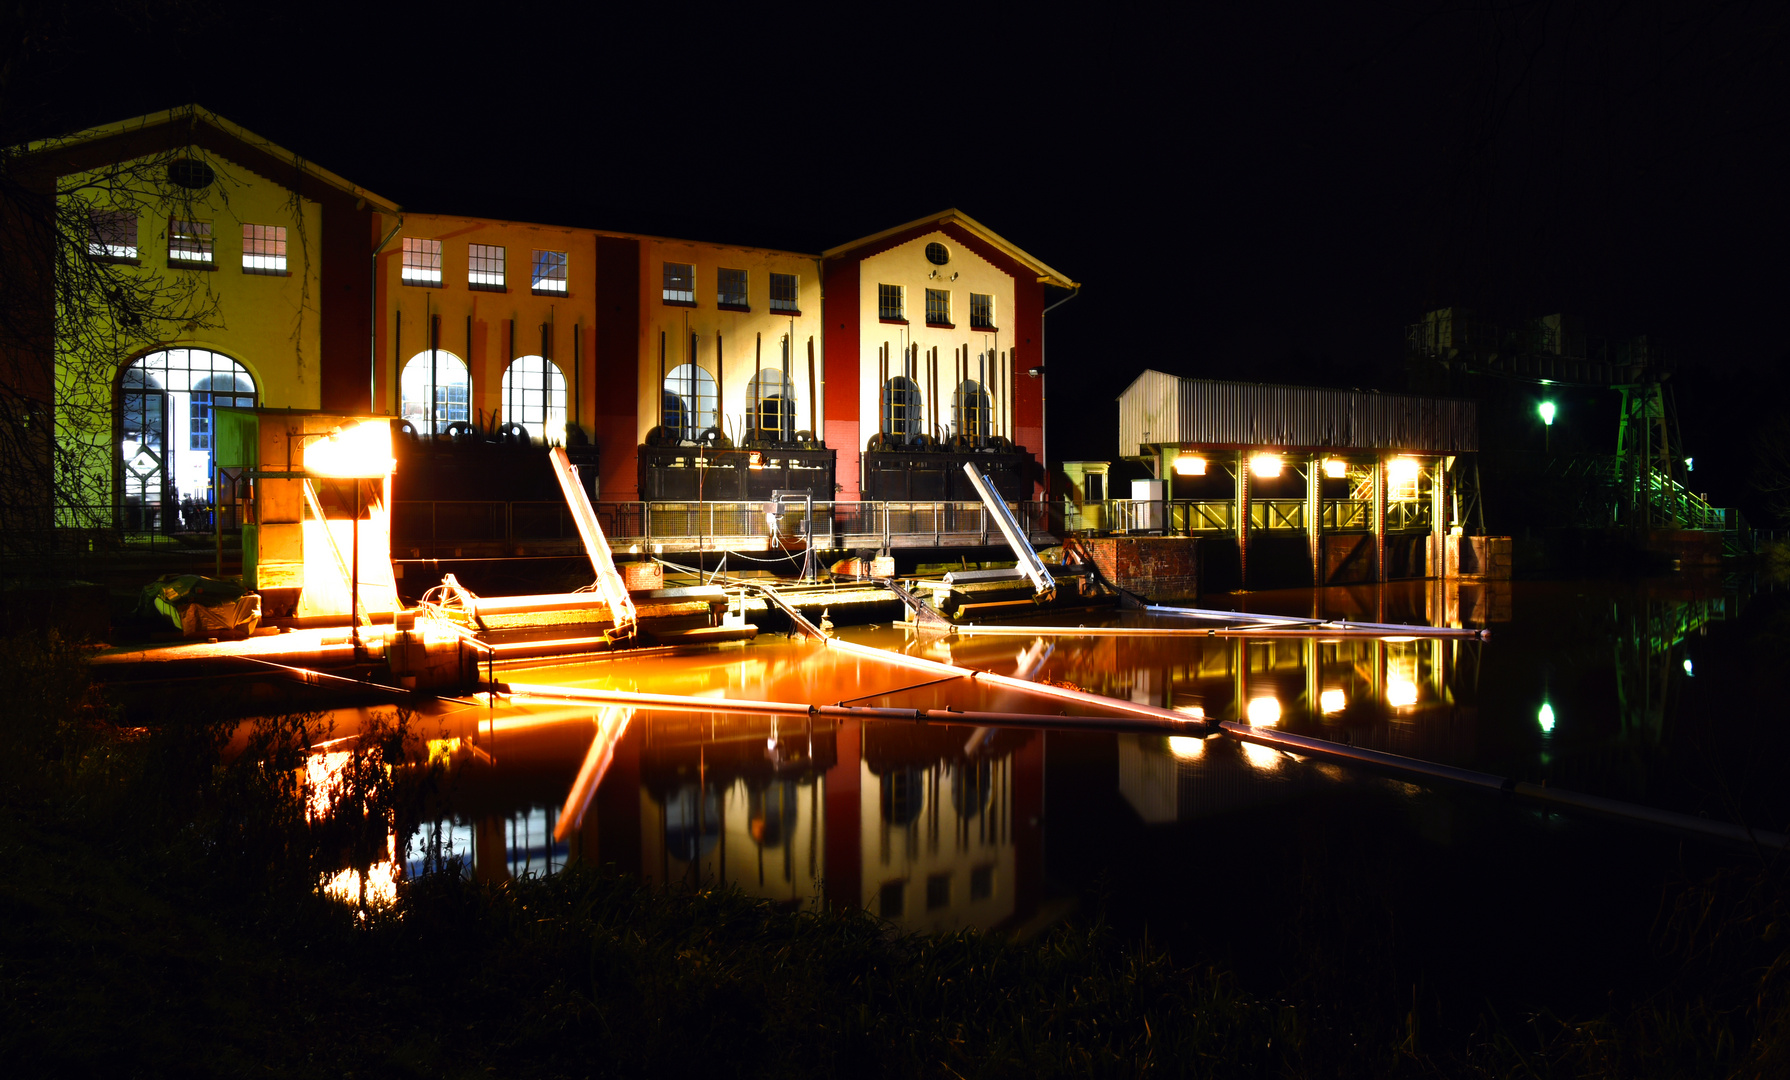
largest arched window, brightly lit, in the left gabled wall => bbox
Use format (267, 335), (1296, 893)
(118, 349), (254, 532)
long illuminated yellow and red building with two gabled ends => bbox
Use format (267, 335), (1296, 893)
(17, 106), (1074, 532)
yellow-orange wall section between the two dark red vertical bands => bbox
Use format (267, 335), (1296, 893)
(635, 238), (827, 442)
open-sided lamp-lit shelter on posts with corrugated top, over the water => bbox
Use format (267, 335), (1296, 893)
(1102, 371), (1484, 587)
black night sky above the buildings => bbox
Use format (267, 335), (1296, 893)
(24, 0), (1790, 512)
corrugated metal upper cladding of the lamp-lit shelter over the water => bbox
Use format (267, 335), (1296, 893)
(1119, 371), (1479, 457)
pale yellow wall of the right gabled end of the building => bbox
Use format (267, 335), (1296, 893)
(855, 231), (1013, 450)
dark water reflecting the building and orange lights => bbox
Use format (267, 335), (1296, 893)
(318, 579), (1790, 1008)
